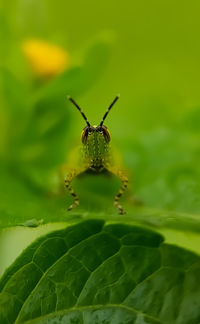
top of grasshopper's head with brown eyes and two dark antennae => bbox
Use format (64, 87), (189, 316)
(68, 95), (119, 144)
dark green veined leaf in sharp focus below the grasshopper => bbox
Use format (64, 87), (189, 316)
(0, 220), (200, 324)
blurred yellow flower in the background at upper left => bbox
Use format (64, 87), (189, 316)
(22, 39), (69, 78)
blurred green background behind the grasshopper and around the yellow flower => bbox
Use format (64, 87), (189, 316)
(0, 0), (200, 274)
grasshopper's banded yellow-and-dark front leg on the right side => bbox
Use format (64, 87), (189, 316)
(108, 168), (128, 215)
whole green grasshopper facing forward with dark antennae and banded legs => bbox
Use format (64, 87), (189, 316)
(65, 95), (128, 214)
